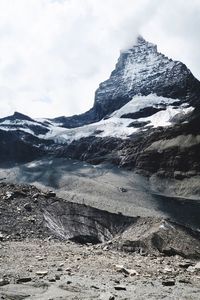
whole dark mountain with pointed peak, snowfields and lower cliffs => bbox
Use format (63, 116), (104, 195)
(0, 36), (200, 191)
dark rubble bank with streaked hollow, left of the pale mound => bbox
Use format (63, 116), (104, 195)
(0, 183), (136, 244)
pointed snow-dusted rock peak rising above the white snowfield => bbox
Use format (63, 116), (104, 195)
(94, 36), (200, 118)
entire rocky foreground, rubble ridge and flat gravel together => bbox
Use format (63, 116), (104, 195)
(0, 182), (200, 300)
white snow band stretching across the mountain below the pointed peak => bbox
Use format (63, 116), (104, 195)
(0, 94), (194, 144)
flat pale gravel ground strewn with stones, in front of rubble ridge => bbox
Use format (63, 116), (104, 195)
(0, 239), (200, 300)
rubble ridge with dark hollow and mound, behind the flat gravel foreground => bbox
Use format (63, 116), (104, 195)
(0, 183), (200, 258)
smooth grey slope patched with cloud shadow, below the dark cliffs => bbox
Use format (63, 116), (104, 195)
(0, 158), (200, 228)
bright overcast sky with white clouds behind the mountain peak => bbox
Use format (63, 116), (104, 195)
(0, 0), (200, 117)
